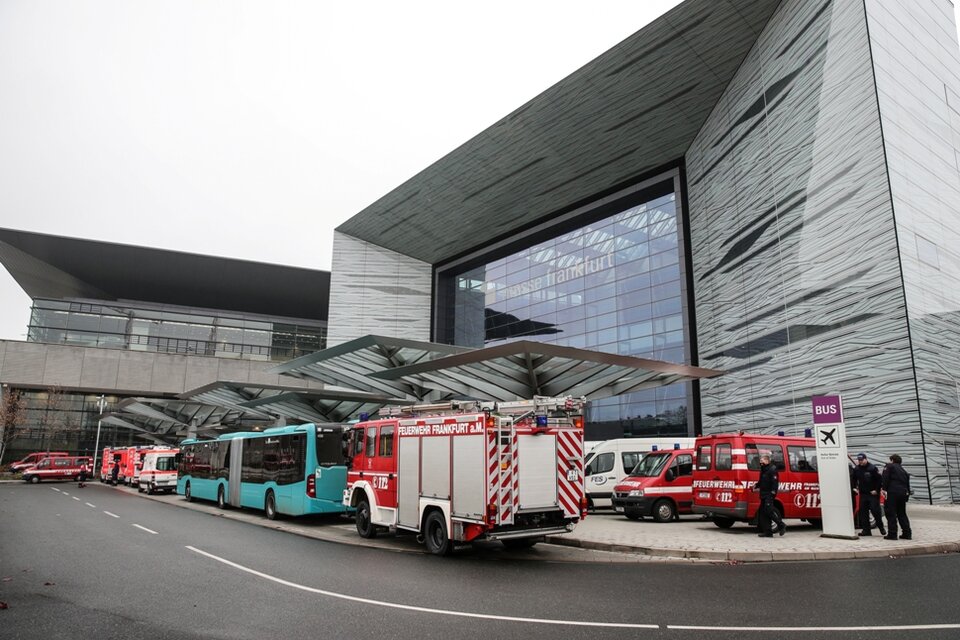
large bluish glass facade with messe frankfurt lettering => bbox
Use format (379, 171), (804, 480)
(437, 193), (690, 439)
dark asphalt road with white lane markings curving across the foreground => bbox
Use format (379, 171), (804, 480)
(0, 484), (960, 640)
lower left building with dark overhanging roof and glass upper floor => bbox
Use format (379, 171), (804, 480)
(0, 229), (330, 463)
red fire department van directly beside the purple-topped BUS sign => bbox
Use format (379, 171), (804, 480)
(693, 433), (821, 528)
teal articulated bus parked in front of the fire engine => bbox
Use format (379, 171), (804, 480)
(177, 424), (347, 520)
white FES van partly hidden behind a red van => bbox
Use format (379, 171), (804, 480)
(584, 436), (696, 509)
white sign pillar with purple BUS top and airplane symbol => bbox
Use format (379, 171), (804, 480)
(811, 395), (857, 540)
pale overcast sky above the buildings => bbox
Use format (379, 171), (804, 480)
(0, 0), (956, 340)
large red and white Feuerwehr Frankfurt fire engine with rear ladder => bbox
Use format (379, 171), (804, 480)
(343, 397), (586, 555)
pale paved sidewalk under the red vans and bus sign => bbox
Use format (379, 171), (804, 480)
(550, 503), (960, 562)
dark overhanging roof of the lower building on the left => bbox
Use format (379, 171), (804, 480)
(0, 228), (330, 321)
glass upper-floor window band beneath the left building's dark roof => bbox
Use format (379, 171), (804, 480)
(27, 298), (327, 361)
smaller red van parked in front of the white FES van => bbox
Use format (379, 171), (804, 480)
(613, 448), (693, 522)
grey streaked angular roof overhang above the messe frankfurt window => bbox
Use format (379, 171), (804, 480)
(337, 0), (780, 264)
